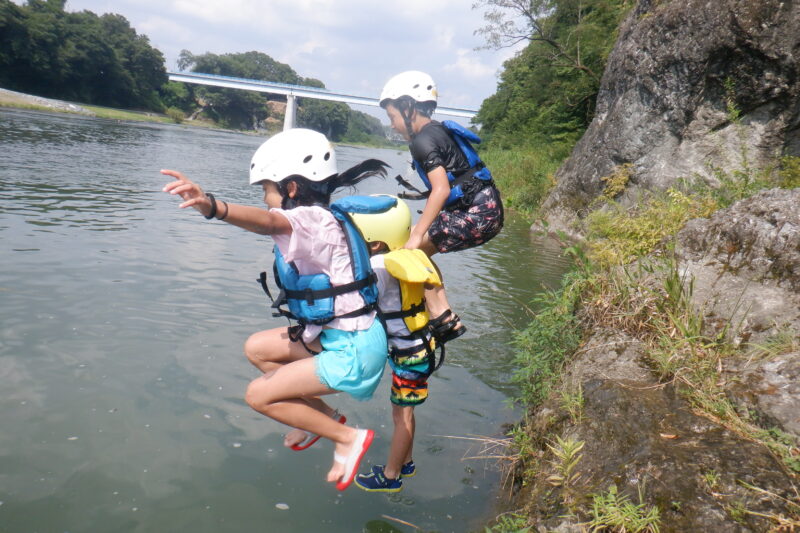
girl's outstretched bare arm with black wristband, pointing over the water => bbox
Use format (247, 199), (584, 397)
(161, 170), (292, 235)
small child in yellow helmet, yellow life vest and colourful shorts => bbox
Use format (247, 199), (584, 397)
(352, 194), (443, 492)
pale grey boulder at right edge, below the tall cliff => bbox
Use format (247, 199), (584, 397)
(677, 189), (800, 343)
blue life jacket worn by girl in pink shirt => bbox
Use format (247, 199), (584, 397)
(259, 196), (397, 325)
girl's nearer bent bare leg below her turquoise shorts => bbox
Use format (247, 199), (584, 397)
(245, 358), (366, 482)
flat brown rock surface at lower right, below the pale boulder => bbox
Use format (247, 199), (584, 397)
(577, 380), (792, 532)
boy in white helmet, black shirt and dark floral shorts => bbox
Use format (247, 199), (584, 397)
(380, 70), (504, 342)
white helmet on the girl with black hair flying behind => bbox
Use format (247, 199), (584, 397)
(250, 128), (338, 185)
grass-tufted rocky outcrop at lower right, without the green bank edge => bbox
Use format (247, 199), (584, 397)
(518, 189), (800, 533)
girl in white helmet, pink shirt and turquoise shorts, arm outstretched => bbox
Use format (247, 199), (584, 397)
(161, 129), (387, 490)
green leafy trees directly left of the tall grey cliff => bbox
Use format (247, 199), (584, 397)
(473, 0), (632, 146)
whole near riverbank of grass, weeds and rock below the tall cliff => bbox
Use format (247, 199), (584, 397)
(484, 158), (800, 532)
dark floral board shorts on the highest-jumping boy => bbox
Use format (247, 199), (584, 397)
(428, 185), (504, 253)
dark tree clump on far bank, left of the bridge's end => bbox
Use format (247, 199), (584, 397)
(0, 0), (167, 110)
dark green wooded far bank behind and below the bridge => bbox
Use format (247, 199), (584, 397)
(0, 0), (385, 143)
